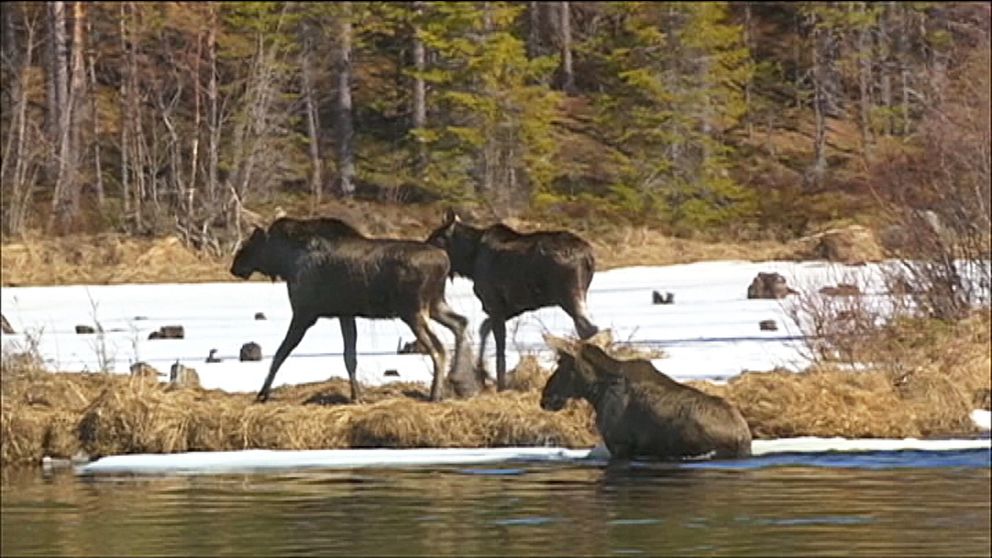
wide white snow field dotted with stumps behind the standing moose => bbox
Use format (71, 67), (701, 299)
(0, 261), (989, 436)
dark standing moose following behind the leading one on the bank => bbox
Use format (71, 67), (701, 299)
(427, 208), (599, 391)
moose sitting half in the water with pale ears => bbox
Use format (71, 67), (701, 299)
(541, 331), (751, 460)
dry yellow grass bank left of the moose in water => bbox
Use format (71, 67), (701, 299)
(0, 356), (596, 465)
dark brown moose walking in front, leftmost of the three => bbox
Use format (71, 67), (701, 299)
(231, 217), (471, 402)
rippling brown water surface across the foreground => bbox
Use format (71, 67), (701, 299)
(0, 450), (992, 556)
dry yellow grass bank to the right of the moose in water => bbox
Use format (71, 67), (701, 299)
(692, 310), (992, 438)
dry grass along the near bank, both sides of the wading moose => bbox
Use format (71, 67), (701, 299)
(0, 315), (990, 465)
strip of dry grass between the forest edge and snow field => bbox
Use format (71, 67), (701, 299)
(0, 201), (879, 286)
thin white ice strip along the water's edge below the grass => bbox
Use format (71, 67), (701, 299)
(77, 437), (990, 475)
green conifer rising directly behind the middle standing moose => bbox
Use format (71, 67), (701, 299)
(414, 2), (560, 210)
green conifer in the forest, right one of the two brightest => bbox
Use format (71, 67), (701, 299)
(581, 2), (752, 228)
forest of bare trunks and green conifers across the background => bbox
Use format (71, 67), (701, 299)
(0, 2), (992, 249)
